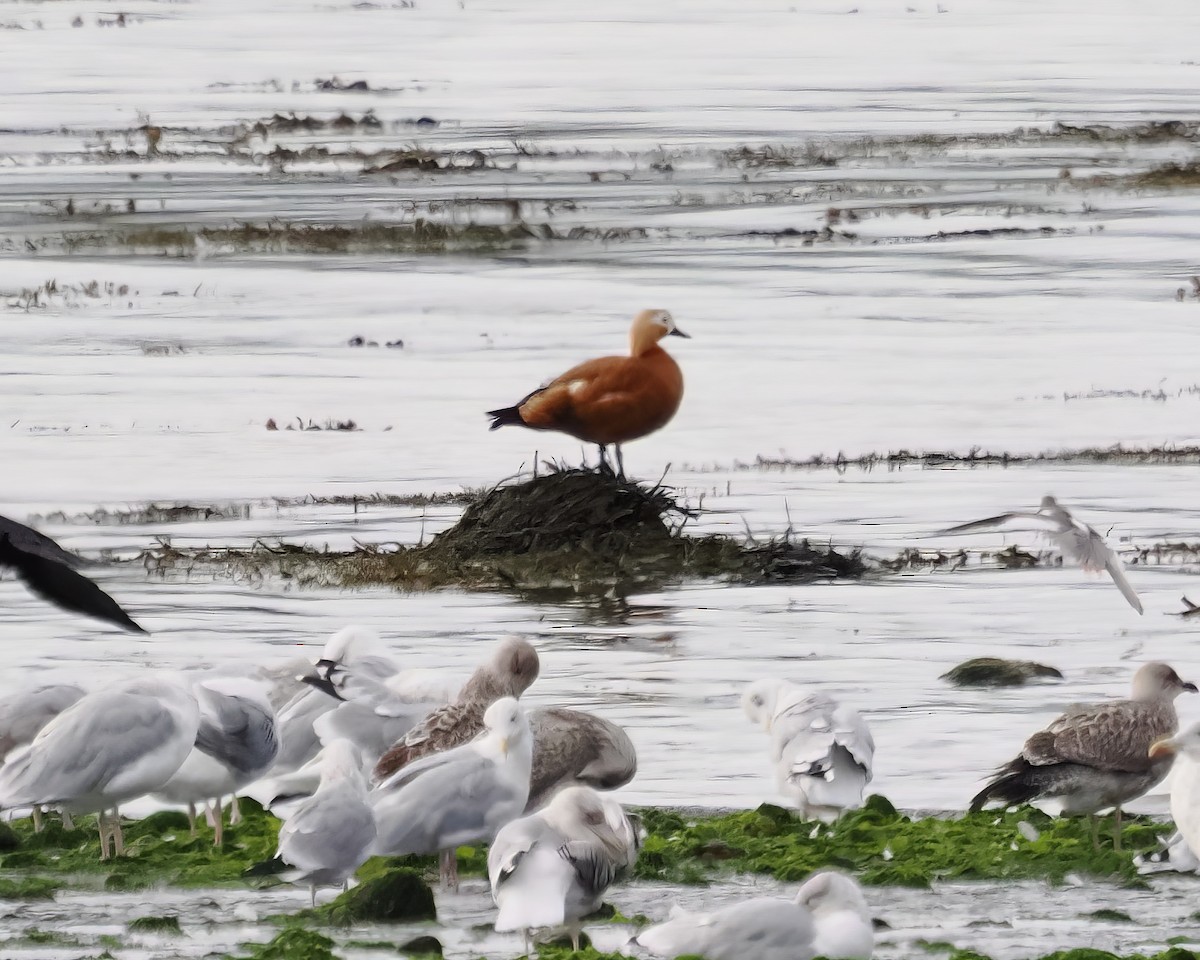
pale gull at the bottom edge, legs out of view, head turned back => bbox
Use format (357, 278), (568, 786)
(634, 871), (874, 960)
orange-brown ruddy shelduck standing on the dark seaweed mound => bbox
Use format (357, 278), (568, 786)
(487, 310), (688, 478)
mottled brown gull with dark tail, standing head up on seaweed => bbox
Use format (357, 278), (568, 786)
(971, 664), (1196, 850)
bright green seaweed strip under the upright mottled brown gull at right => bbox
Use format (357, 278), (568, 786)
(635, 796), (1162, 887)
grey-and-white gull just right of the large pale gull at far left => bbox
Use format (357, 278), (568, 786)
(154, 677), (280, 846)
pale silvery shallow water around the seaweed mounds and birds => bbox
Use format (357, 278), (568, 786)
(0, 0), (1200, 958)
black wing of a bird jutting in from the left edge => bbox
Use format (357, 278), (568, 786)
(0, 517), (146, 634)
